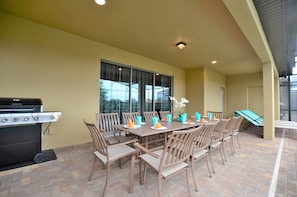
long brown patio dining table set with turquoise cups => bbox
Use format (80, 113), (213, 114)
(114, 120), (216, 148)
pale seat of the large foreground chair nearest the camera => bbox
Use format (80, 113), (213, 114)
(140, 150), (188, 178)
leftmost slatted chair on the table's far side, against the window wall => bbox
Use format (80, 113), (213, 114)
(96, 113), (131, 144)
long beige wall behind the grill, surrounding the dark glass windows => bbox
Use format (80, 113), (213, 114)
(0, 12), (186, 149)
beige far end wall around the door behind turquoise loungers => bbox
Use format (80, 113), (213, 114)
(226, 73), (263, 117)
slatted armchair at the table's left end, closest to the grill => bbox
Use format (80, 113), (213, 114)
(83, 120), (137, 196)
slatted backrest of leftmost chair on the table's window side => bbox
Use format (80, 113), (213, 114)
(96, 113), (121, 132)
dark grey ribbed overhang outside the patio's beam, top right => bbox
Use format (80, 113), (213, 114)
(254, 0), (297, 76)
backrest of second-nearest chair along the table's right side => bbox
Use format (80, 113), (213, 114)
(194, 122), (218, 150)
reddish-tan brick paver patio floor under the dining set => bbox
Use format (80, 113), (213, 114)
(0, 127), (297, 197)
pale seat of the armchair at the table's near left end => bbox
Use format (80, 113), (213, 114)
(94, 145), (135, 165)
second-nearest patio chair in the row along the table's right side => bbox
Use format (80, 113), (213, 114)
(191, 123), (218, 191)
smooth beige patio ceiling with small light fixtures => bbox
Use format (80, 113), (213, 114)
(0, 0), (262, 75)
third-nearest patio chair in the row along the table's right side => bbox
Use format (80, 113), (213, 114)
(209, 118), (231, 173)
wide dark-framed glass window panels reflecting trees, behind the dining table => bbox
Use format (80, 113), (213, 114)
(99, 61), (172, 118)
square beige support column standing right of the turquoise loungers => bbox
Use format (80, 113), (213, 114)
(263, 62), (275, 140)
